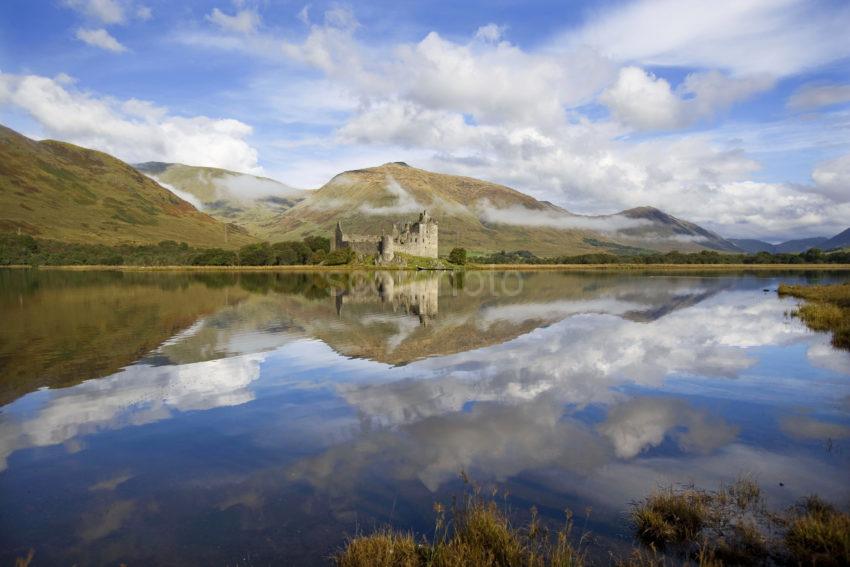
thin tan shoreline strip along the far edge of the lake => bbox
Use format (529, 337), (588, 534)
(0, 264), (850, 272)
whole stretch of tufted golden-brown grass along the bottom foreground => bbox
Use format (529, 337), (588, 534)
(334, 479), (850, 567)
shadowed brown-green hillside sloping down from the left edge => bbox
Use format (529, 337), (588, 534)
(0, 126), (254, 247)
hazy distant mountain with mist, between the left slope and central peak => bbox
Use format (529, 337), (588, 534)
(134, 162), (309, 238)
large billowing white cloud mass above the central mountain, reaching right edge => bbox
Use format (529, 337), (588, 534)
(260, 5), (847, 237)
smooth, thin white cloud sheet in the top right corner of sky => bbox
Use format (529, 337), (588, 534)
(552, 0), (850, 77)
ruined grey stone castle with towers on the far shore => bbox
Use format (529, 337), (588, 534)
(331, 211), (437, 262)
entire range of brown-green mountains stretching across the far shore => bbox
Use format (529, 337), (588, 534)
(0, 126), (850, 256)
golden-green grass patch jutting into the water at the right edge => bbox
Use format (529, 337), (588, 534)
(778, 283), (850, 350)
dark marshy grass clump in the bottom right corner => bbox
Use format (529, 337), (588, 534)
(621, 478), (850, 566)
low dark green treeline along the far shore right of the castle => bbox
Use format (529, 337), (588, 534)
(472, 248), (850, 265)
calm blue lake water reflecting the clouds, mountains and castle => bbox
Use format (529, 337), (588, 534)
(0, 270), (850, 565)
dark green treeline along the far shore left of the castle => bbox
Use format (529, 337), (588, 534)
(0, 234), (332, 266)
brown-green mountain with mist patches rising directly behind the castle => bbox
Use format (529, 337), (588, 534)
(268, 162), (737, 255)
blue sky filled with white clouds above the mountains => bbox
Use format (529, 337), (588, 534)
(0, 0), (850, 242)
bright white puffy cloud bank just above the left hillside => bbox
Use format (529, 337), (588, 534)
(0, 73), (262, 173)
